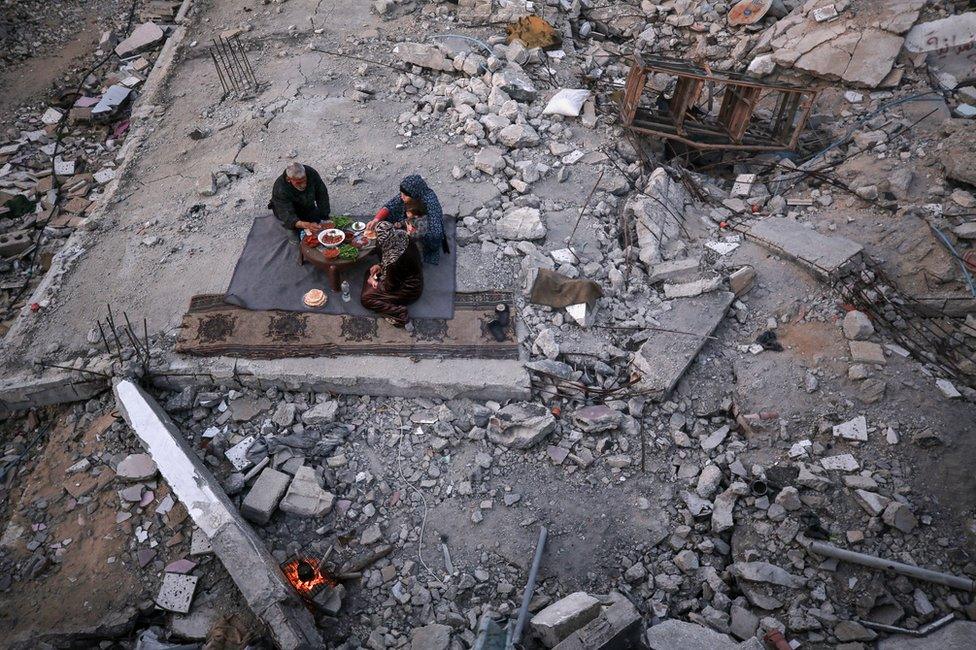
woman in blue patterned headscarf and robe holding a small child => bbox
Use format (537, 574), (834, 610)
(370, 174), (448, 264)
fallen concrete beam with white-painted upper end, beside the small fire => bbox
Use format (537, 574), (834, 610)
(113, 379), (324, 650)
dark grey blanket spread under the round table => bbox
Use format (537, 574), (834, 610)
(224, 214), (457, 319)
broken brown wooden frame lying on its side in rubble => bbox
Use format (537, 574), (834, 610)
(620, 54), (819, 151)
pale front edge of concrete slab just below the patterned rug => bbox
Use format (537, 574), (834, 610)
(152, 356), (531, 401)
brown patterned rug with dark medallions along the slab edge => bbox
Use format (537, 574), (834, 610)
(176, 291), (518, 359)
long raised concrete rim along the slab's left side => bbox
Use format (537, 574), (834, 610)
(0, 0), (194, 363)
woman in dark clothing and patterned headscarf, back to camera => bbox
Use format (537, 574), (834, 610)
(362, 221), (424, 327)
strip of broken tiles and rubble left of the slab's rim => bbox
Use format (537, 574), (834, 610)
(0, 22), (173, 332)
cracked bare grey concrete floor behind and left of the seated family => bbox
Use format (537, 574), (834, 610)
(3, 1), (528, 368)
